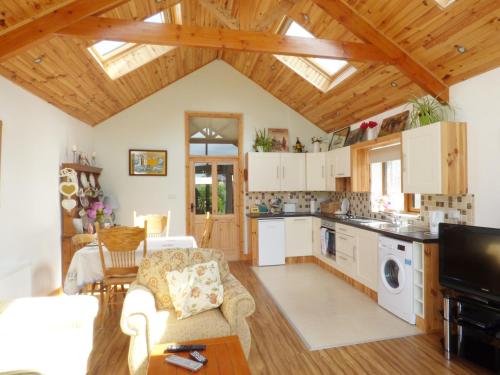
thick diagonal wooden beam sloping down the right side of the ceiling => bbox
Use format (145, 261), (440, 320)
(313, 0), (449, 102)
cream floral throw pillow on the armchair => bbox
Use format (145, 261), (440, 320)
(166, 260), (224, 319)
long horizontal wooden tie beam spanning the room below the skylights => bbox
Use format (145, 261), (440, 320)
(58, 17), (392, 63)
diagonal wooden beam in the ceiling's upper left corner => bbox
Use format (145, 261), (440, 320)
(0, 0), (128, 61)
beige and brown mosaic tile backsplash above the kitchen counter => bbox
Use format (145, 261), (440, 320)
(245, 192), (474, 226)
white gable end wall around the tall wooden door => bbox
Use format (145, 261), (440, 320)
(95, 61), (324, 238)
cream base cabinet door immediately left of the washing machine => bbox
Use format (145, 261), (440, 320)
(355, 229), (378, 291)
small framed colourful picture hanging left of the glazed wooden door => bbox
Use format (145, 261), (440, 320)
(128, 150), (167, 176)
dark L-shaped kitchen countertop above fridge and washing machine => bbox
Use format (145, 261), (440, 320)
(247, 212), (439, 243)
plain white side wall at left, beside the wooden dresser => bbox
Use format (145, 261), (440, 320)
(0, 77), (92, 299)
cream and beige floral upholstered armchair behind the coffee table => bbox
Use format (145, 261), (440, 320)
(120, 249), (255, 375)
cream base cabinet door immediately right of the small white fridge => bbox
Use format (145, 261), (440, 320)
(285, 216), (312, 257)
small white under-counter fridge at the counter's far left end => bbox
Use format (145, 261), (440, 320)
(259, 219), (285, 266)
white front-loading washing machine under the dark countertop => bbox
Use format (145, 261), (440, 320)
(378, 236), (415, 324)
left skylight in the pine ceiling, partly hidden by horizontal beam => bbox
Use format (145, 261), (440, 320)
(89, 3), (182, 79)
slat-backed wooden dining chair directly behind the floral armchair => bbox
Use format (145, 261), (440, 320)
(96, 221), (148, 326)
